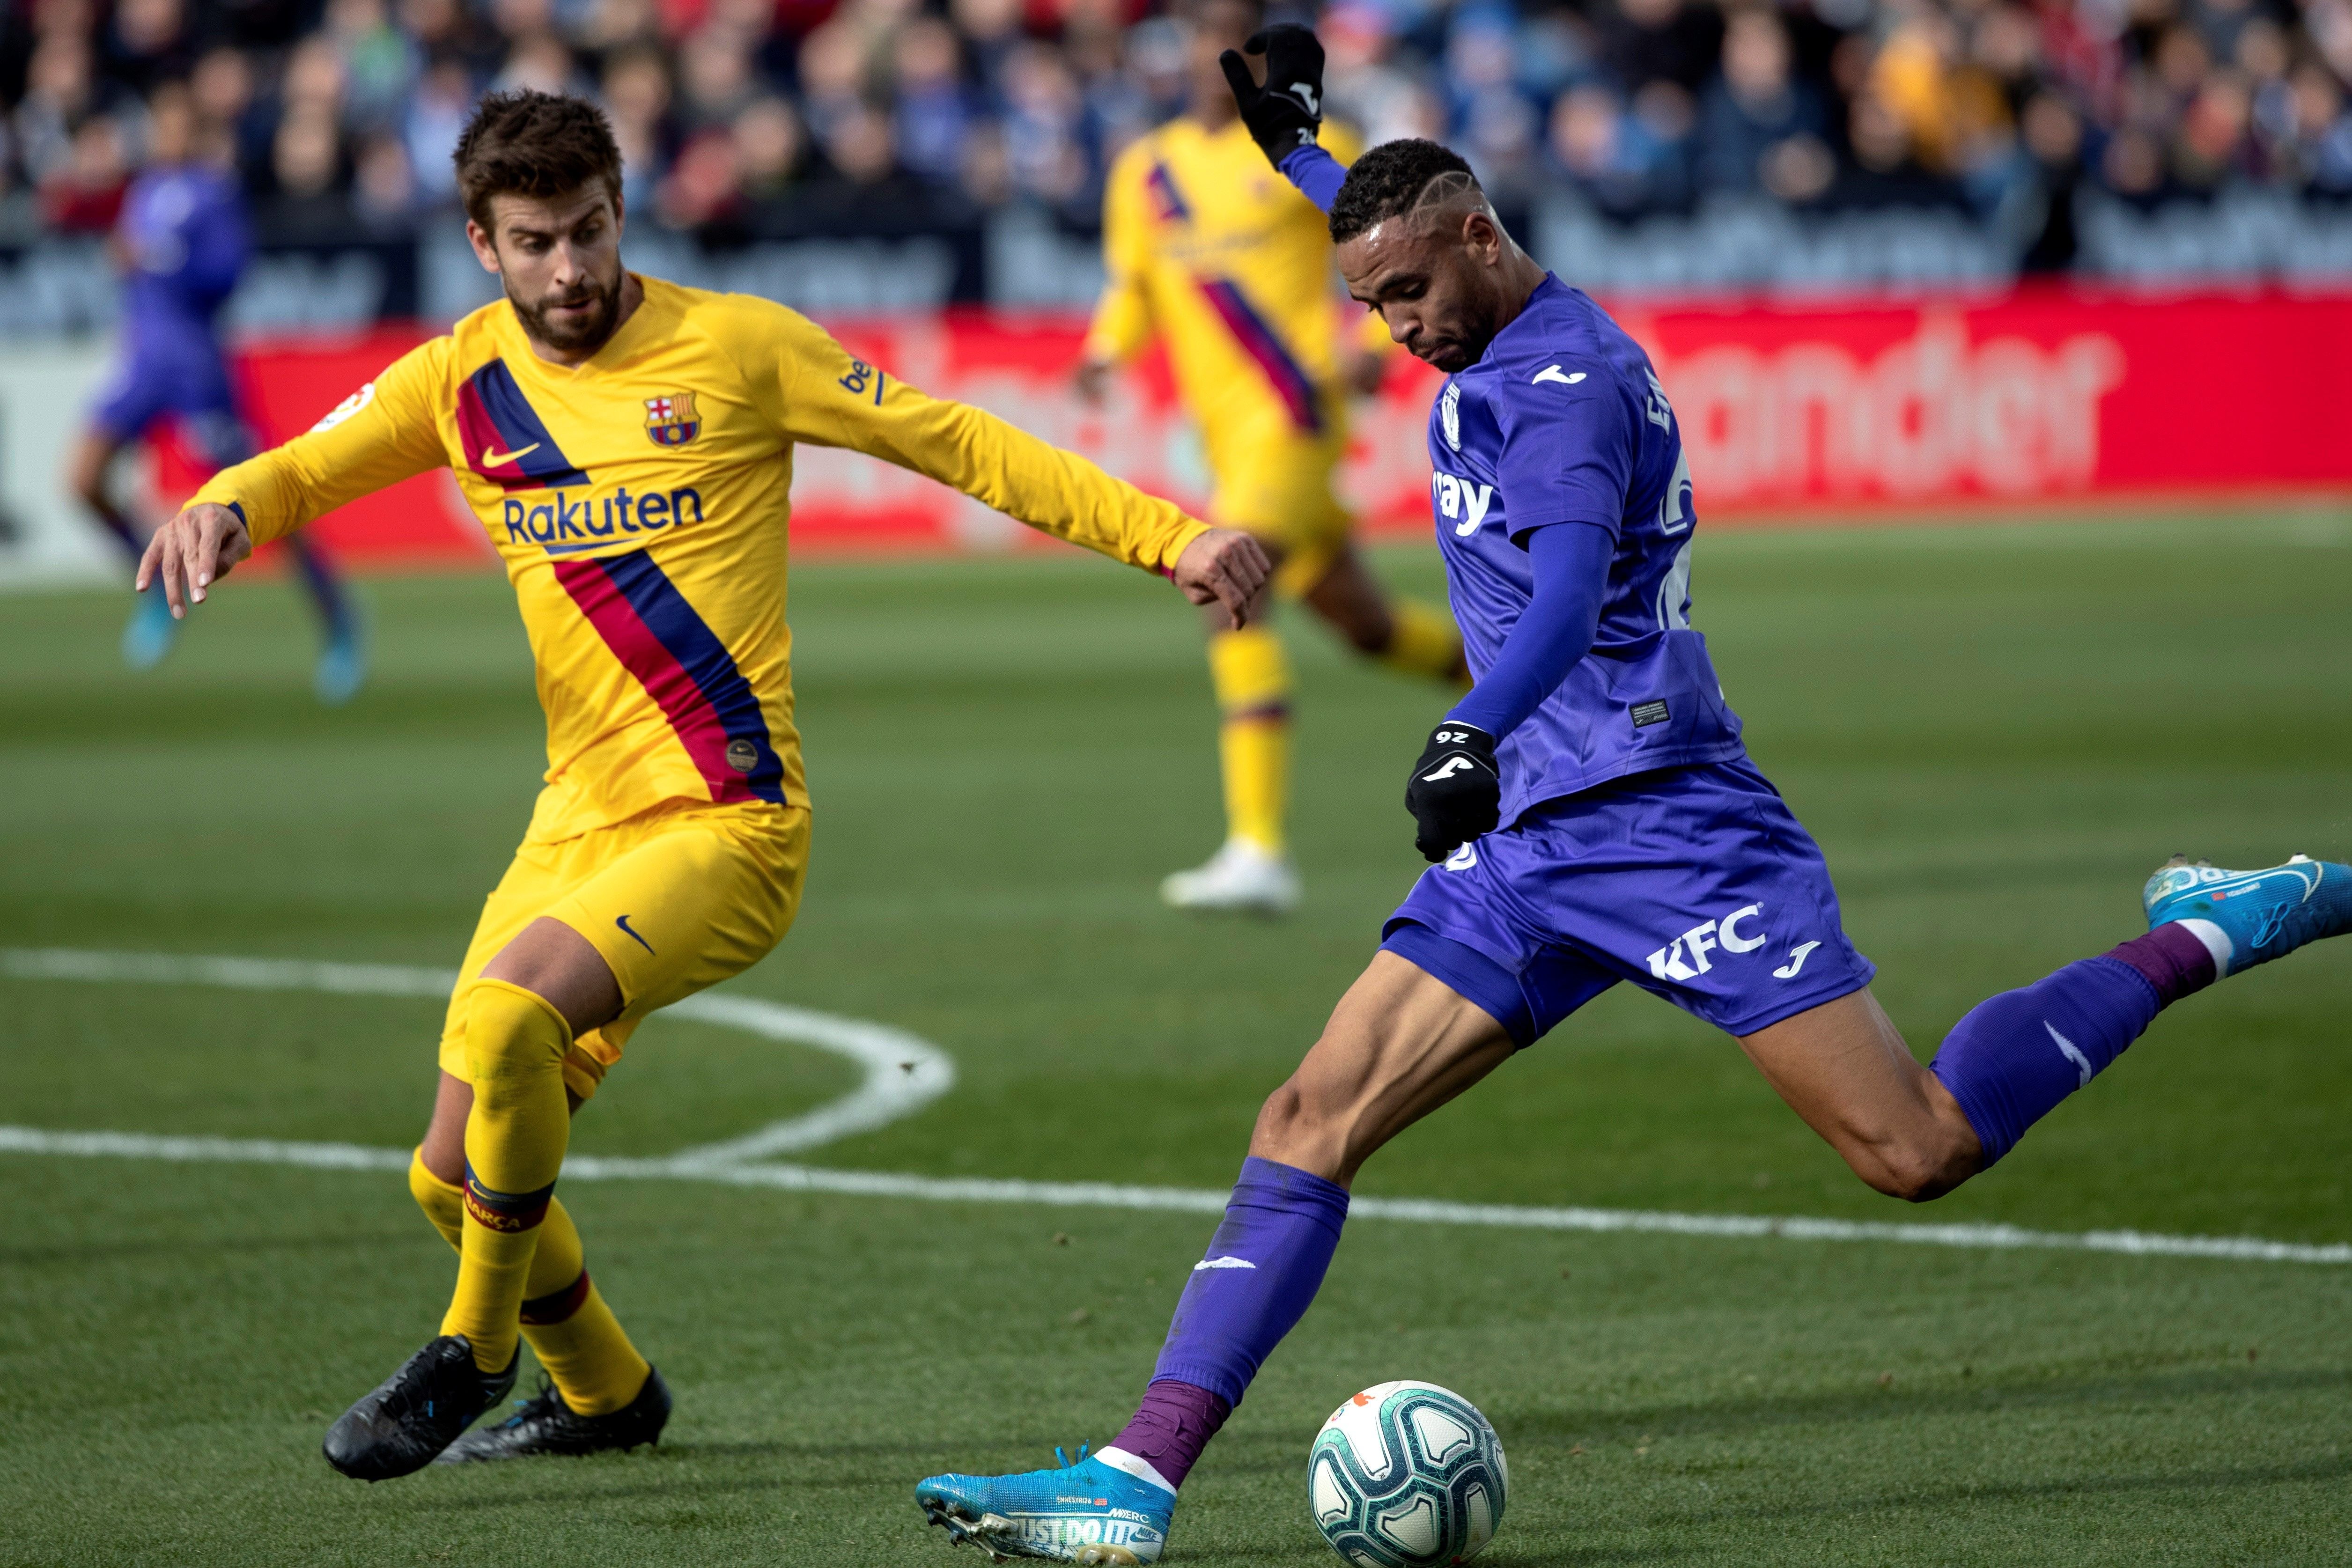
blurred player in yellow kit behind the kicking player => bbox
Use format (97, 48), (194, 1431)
(1080, 0), (1467, 912)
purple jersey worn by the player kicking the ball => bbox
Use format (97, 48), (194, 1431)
(1430, 275), (1743, 827)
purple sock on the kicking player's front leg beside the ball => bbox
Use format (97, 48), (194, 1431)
(1110, 1154), (1348, 1486)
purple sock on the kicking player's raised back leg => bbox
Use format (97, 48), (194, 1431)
(1929, 924), (2213, 1166)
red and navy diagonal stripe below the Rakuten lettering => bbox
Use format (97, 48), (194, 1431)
(555, 550), (786, 806)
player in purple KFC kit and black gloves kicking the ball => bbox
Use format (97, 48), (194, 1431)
(915, 28), (2352, 1563)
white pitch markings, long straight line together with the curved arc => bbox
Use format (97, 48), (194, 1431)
(0, 950), (2352, 1265)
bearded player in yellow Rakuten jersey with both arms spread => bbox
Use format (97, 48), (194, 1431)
(139, 92), (1270, 1481)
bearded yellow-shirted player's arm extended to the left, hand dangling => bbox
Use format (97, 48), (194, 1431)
(136, 339), (449, 616)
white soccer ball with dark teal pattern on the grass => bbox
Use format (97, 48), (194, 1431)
(1308, 1382), (1510, 1568)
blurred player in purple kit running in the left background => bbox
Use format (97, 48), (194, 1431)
(68, 82), (367, 703)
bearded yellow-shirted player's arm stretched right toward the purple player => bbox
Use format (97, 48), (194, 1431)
(736, 308), (1272, 616)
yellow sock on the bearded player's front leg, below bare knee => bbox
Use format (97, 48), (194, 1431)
(442, 980), (572, 1373)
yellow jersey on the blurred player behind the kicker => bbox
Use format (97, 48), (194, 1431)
(1087, 115), (1359, 447)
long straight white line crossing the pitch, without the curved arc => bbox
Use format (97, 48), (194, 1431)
(0, 1126), (2352, 1265)
